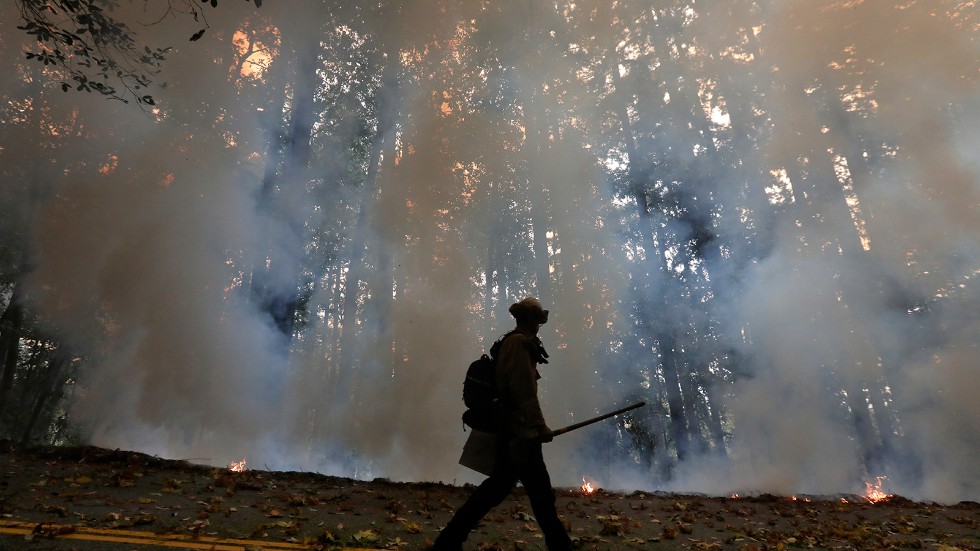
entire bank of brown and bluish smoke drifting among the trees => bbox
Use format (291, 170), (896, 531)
(0, 2), (980, 501)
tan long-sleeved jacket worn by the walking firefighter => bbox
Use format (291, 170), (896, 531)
(497, 331), (550, 440)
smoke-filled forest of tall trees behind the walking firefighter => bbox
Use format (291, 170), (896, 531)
(0, 0), (980, 502)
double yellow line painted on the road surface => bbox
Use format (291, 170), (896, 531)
(0, 520), (372, 551)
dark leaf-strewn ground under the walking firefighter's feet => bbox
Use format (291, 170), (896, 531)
(0, 447), (980, 551)
